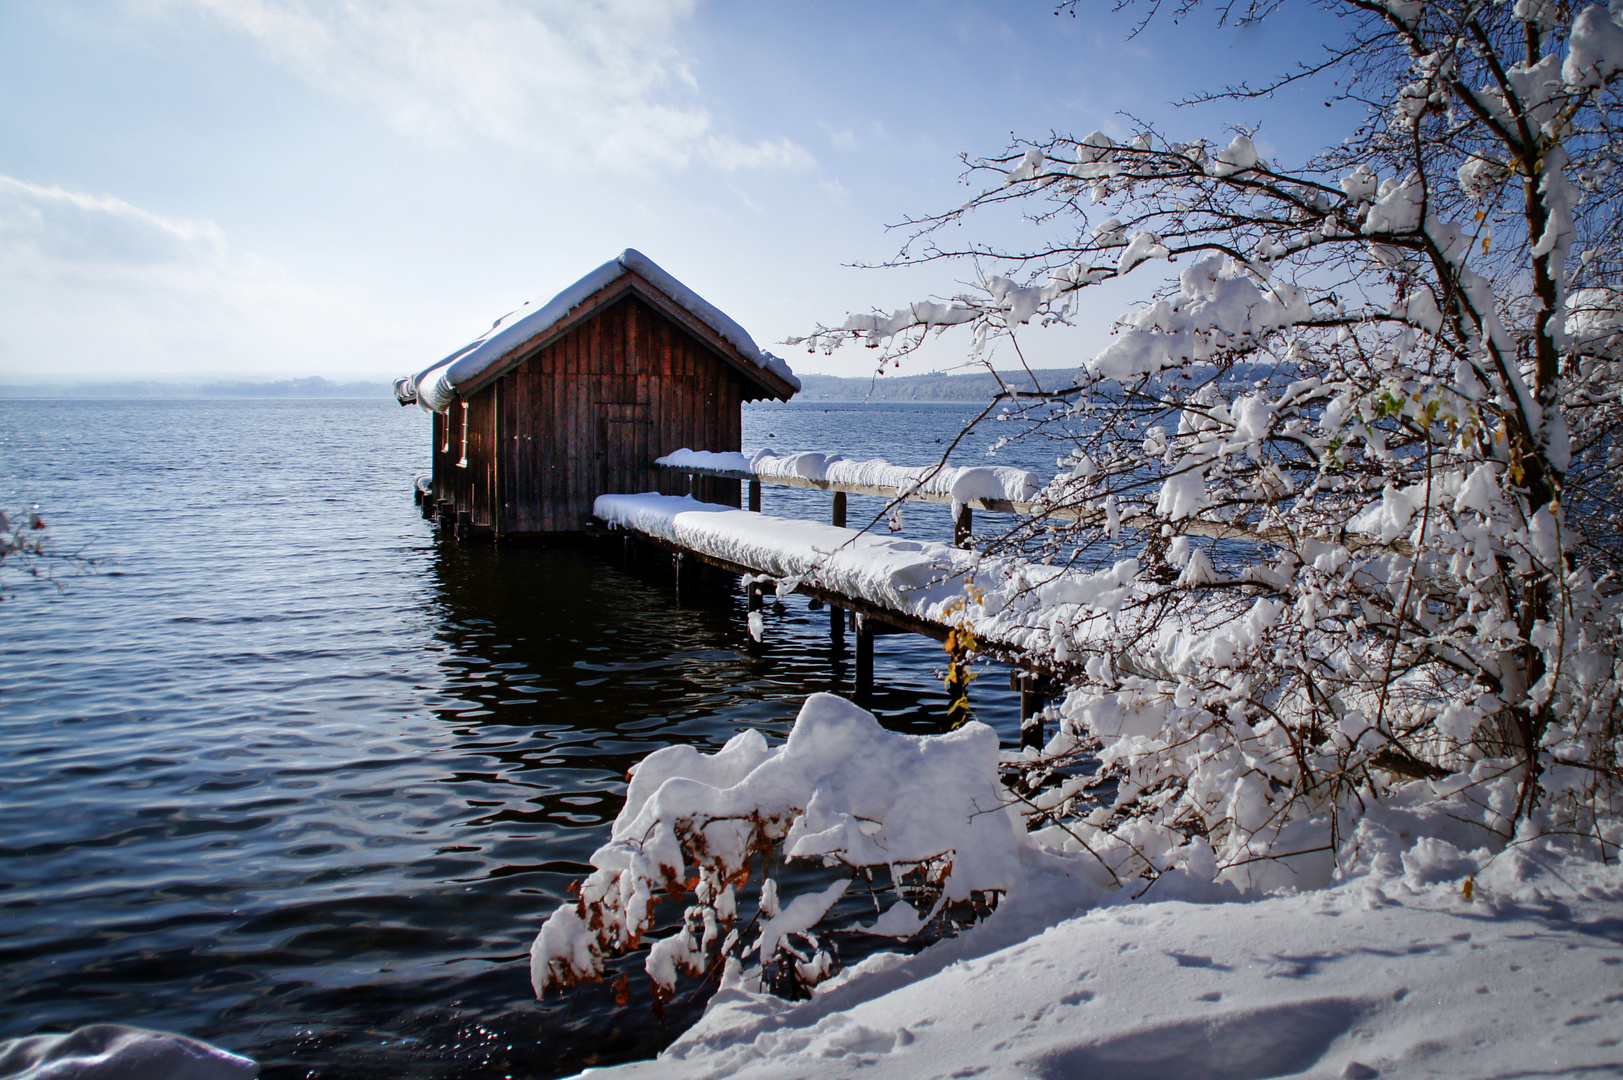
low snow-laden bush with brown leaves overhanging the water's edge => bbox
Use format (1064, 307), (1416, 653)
(531, 693), (1022, 1000)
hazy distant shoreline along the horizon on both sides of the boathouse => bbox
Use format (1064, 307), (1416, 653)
(0, 369), (1076, 401)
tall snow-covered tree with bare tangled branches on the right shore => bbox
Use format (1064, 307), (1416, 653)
(536, 0), (1623, 1006)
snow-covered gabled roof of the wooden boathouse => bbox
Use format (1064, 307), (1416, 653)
(394, 247), (800, 413)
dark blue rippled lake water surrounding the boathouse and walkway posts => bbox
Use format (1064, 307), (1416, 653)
(0, 401), (1052, 1080)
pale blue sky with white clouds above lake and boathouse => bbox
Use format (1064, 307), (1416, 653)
(0, 0), (1357, 383)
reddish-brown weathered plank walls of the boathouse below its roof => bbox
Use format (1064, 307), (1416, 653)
(433, 274), (792, 538)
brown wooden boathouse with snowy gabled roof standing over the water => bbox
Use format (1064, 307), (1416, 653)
(394, 248), (800, 538)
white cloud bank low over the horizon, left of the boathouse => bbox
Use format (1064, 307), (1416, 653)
(0, 175), (443, 382)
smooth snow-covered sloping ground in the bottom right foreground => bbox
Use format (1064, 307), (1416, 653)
(583, 841), (1623, 1080)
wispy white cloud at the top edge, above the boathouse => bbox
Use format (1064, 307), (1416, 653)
(133, 0), (812, 172)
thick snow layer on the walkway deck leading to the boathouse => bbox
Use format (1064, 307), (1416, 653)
(592, 493), (1138, 661)
